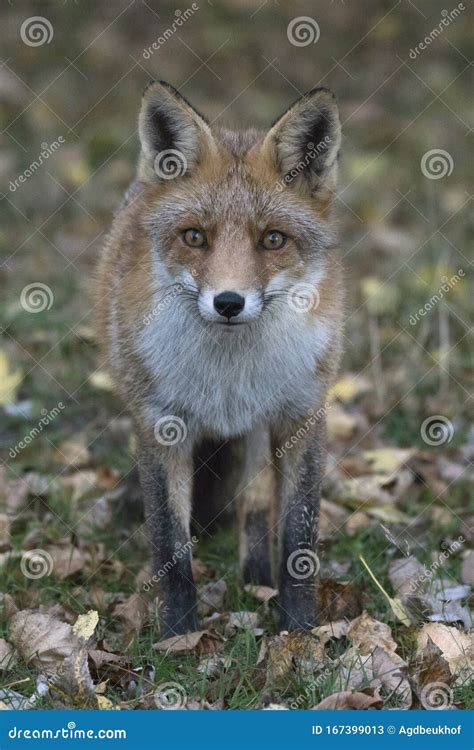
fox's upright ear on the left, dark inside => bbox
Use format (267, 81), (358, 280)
(138, 81), (214, 182)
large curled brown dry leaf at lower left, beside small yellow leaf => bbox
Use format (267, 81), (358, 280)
(10, 609), (79, 674)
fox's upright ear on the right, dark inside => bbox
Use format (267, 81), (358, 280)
(263, 88), (341, 199)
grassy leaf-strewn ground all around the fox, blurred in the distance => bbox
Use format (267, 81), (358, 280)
(0, 0), (474, 709)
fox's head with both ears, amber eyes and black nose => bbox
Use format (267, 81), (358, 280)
(138, 82), (341, 330)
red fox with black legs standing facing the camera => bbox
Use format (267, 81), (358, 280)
(97, 82), (343, 635)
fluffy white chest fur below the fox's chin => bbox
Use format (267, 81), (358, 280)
(134, 301), (329, 438)
